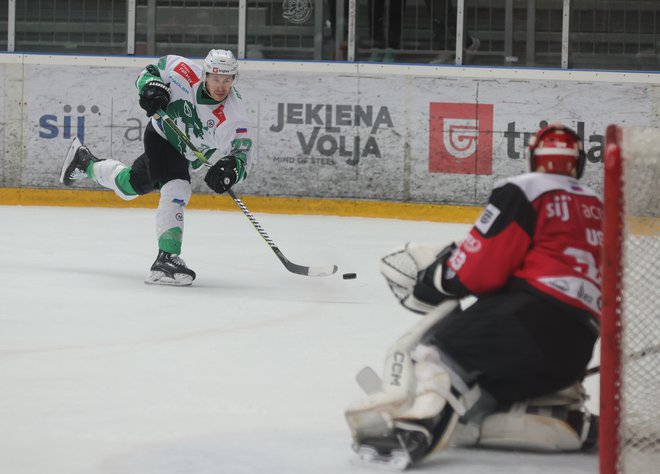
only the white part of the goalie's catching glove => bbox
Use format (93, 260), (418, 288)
(380, 242), (454, 314)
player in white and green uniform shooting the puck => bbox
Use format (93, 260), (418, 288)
(60, 49), (252, 286)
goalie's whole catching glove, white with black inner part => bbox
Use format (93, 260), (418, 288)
(380, 242), (456, 314)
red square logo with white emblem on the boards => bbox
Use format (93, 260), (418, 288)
(429, 102), (493, 174)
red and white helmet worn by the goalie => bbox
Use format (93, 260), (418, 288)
(528, 124), (586, 178)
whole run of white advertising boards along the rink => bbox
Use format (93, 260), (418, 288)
(9, 58), (658, 205)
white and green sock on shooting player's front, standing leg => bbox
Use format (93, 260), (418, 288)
(156, 179), (192, 255)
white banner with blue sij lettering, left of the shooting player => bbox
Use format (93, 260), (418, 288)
(22, 61), (148, 189)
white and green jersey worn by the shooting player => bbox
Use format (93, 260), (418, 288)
(136, 55), (252, 182)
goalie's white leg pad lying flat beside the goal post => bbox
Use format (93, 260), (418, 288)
(472, 383), (592, 451)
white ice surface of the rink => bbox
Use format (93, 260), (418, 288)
(0, 207), (597, 474)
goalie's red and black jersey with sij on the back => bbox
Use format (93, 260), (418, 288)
(443, 173), (603, 319)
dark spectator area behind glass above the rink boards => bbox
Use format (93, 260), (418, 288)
(0, 0), (660, 71)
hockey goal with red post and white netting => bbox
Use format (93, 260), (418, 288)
(599, 125), (660, 474)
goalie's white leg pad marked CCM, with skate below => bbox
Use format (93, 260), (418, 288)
(345, 346), (468, 467)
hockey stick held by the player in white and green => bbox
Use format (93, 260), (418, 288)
(154, 109), (337, 276)
